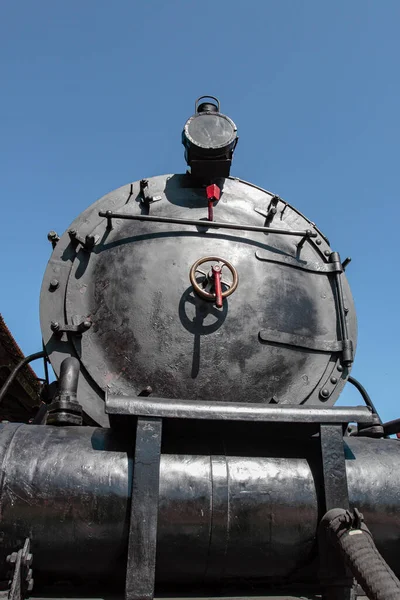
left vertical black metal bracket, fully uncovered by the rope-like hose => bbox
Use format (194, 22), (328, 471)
(125, 417), (162, 600)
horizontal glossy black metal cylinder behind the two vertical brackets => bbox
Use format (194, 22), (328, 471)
(0, 423), (400, 595)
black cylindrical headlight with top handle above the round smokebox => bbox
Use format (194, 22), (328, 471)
(182, 96), (238, 182)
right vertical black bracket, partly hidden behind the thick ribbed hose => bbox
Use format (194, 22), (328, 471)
(319, 423), (356, 600)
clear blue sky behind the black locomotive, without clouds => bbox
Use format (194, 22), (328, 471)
(0, 0), (400, 419)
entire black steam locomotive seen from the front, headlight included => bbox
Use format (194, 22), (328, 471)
(0, 96), (400, 600)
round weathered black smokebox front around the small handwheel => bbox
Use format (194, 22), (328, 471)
(41, 175), (356, 425)
